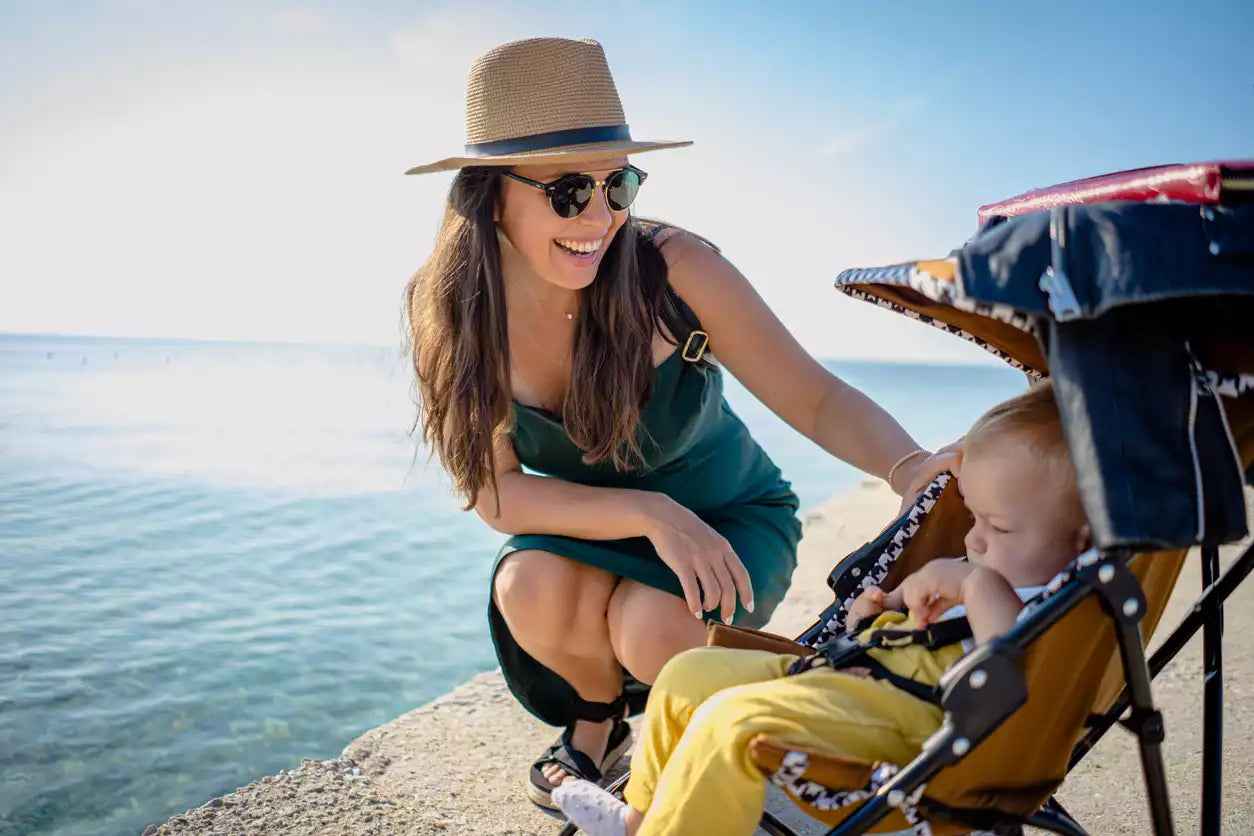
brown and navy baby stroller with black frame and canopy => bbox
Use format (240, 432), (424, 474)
(563, 160), (1254, 836)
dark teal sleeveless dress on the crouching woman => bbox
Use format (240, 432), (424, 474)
(488, 320), (801, 726)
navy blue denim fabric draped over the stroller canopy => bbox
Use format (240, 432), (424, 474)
(954, 203), (1254, 550)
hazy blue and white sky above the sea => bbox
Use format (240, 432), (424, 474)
(0, 0), (1254, 361)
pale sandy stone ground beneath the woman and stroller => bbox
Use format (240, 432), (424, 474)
(144, 483), (1254, 836)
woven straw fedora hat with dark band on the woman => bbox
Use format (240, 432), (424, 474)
(405, 38), (692, 174)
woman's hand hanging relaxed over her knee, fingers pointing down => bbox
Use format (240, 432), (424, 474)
(645, 494), (754, 624)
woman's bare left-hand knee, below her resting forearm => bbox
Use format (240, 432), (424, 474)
(492, 549), (616, 651)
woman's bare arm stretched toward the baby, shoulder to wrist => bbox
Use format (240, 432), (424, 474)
(662, 233), (927, 493)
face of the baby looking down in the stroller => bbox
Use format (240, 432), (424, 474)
(958, 440), (1088, 587)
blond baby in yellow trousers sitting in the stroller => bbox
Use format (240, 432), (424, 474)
(553, 382), (1090, 836)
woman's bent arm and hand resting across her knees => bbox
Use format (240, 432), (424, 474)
(474, 434), (754, 623)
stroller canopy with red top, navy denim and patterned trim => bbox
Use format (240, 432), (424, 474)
(836, 160), (1254, 550)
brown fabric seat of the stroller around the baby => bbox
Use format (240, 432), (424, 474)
(727, 485), (1203, 836)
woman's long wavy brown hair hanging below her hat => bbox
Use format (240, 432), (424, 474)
(405, 167), (706, 514)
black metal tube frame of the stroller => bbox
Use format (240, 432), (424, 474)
(762, 545), (1254, 836)
